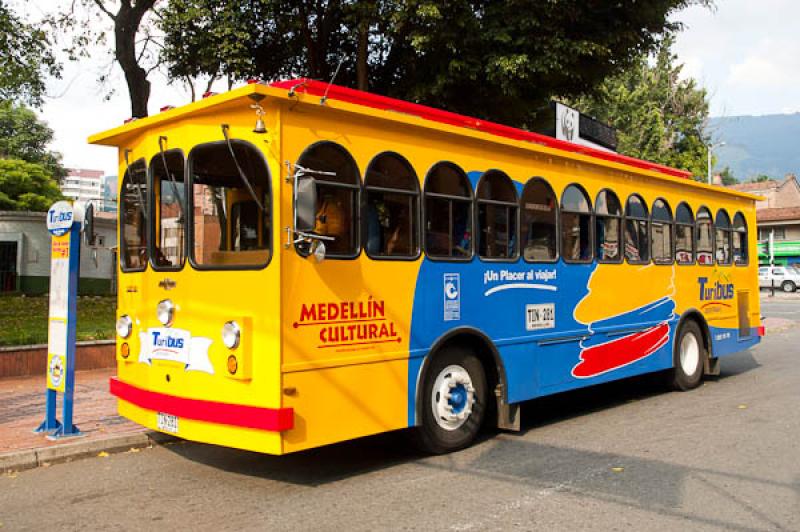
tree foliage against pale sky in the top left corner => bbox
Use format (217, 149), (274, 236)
(0, 1), (61, 107)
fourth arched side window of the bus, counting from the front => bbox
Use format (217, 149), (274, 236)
(476, 170), (517, 259)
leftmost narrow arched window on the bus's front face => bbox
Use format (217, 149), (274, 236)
(119, 159), (149, 272)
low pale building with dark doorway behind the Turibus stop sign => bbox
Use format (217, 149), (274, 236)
(0, 211), (117, 295)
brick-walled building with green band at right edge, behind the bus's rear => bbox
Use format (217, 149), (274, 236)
(731, 174), (800, 265)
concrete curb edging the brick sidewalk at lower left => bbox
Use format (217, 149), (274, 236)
(0, 432), (176, 474)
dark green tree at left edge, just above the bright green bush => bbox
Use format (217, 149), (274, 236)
(0, 101), (67, 180)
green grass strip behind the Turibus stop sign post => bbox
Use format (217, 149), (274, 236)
(0, 296), (117, 346)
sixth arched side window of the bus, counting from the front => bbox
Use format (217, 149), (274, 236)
(561, 185), (592, 262)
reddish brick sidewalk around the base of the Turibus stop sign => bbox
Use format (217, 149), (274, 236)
(0, 368), (162, 473)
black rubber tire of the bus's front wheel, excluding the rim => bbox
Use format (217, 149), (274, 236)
(416, 347), (487, 454)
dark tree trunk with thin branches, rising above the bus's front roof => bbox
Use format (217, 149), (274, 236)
(48, 0), (158, 118)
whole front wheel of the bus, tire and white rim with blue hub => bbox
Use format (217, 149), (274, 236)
(417, 347), (486, 454)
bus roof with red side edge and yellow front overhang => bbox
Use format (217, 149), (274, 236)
(88, 78), (761, 200)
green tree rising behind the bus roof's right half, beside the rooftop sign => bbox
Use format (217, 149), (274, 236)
(573, 37), (709, 180)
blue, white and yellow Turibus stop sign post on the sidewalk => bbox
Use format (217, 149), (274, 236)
(35, 201), (83, 439)
